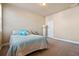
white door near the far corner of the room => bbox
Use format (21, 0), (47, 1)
(46, 16), (54, 38)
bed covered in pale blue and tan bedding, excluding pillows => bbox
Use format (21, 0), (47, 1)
(7, 29), (47, 56)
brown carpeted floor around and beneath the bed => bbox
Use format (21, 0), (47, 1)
(0, 39), (79, 56)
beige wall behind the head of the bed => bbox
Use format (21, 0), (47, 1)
(3, 4), (45, 42)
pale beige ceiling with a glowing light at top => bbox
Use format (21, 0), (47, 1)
(8, 3), (78, 16)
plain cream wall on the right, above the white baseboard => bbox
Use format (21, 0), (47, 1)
(45, 6), (79, 41)
